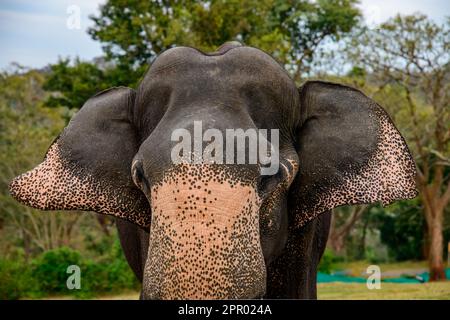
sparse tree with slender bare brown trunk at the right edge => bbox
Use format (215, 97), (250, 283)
(347, 14), (450, 280)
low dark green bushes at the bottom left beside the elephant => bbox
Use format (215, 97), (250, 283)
(0, 241), (139, 299)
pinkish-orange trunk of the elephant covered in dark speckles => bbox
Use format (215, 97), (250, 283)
(143, 166), (266, 299)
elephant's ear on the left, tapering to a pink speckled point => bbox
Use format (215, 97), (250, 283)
(10, 87), (150, 227)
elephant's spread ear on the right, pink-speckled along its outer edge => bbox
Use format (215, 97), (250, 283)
(290, 81), (417, 226)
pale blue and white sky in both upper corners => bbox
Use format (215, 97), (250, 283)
(0, 0), (450, 69)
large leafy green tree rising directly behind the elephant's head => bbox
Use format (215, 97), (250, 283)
(89, 0), (360, 80)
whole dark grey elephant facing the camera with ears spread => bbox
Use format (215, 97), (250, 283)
(10, 42), (417, 299)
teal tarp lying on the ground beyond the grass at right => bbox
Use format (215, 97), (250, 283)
(317, 268), (450, 283)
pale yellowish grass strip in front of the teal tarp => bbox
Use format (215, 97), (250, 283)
(317, 281), (450, 300)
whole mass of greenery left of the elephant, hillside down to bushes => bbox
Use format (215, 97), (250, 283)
(0, 68), (138, 299)
